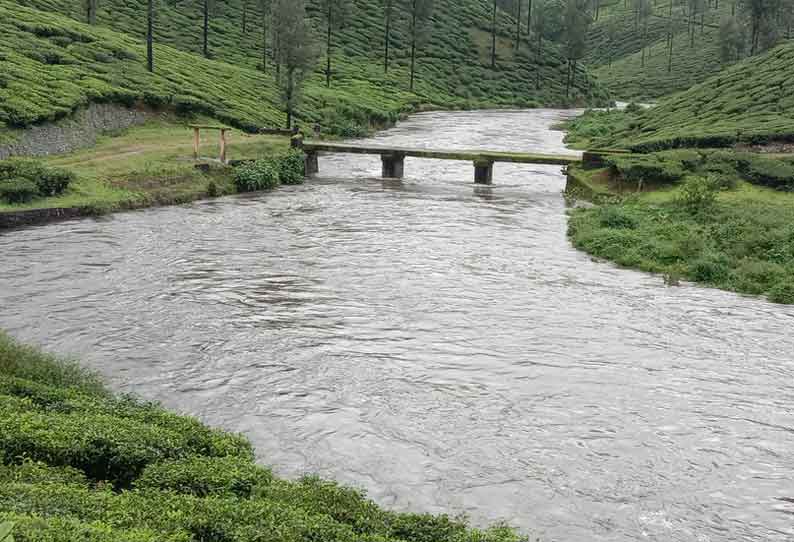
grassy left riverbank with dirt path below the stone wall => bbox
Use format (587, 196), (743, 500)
(0, 115), (289, 229)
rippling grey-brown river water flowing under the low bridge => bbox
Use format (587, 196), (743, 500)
(0, 110), (794, 542)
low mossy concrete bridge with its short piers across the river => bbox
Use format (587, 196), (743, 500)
(293, 138), (582, 184)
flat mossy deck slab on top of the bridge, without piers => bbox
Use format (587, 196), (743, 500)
(303, 141), (582, 166)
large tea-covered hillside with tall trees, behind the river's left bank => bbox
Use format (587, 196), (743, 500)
(0, 0), (605, 137)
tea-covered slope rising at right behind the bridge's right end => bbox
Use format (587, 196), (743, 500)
(571, 43), (794, 151)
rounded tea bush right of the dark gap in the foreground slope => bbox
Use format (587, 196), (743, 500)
(135, 456), (273, 498)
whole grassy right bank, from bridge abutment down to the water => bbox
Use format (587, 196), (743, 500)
(568, 157), (794, 303)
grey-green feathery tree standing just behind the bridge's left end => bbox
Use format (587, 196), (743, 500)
(273, 0), (317, 129)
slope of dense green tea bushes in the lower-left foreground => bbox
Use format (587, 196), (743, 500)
(0, 333), (521, 542)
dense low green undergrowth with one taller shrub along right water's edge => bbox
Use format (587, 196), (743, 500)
(568, 191), (794, 304)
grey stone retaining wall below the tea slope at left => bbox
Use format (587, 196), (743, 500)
(0, 104), (152, 160)
